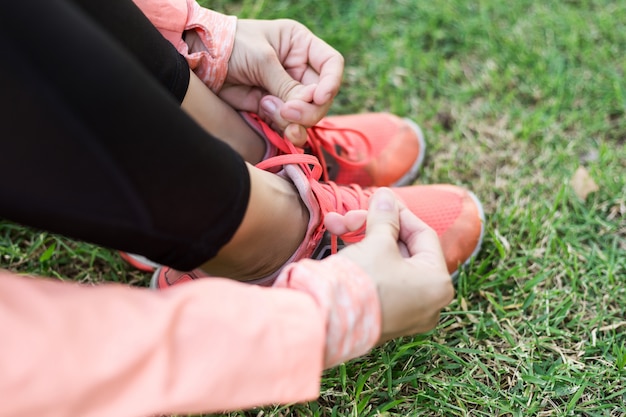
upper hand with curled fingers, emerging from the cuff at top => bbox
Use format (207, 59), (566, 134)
(219, 19), (344, 146)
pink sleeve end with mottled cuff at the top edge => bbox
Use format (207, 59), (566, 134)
(134, 0), (237, 93)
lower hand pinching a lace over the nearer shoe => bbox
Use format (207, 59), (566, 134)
(325, 188), (454, 343)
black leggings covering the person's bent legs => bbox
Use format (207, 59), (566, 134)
(0, 0), (250, 270)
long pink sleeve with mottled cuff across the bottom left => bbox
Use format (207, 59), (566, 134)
(0, 257), (380, 417)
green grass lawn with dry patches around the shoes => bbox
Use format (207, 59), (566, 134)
(0, 0), (626, 417)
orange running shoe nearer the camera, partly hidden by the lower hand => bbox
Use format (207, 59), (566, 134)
(152, 140), (485, 289)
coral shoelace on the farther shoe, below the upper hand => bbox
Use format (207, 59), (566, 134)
(249, 113), (373, 181)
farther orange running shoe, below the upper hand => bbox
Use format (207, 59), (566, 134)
(242, 113), (426, 187)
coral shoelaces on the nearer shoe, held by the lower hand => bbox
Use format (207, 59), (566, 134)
(256, 117), (372, 254)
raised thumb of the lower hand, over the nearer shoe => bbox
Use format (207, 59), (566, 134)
(365, 187), (400, 245)
